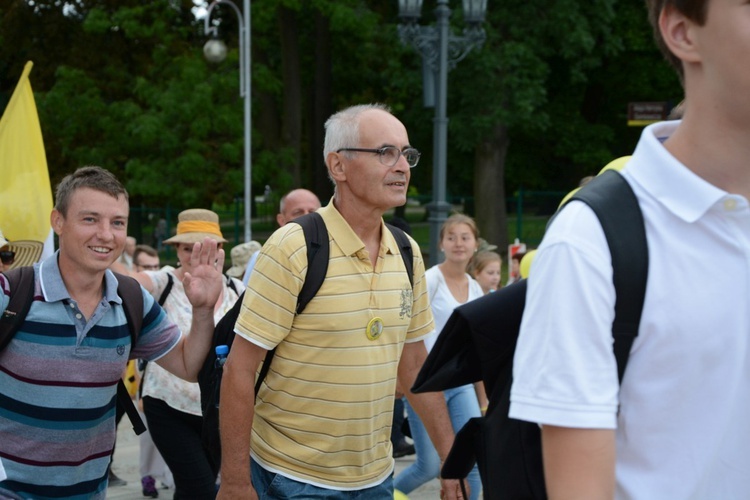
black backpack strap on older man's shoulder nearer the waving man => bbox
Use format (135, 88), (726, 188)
(255, 212), (330, 398)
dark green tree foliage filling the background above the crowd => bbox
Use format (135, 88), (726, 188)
(0, 0), (681, 245)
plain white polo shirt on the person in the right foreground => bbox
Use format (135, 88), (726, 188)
(510, 122), (750, 499)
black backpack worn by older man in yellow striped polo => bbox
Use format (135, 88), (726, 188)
(198, 212), (414, 464)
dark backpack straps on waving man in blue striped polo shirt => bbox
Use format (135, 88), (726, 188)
(0, 266), (146, 435)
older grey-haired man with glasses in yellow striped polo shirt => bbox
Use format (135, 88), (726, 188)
(219, 104), (461, 499)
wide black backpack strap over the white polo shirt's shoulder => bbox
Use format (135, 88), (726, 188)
(571, 170), (648, 381)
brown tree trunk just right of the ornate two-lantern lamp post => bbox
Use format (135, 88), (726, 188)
(474, 125), (509, 255)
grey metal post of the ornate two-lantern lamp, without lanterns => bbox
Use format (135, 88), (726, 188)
(429, 0), (451, 266)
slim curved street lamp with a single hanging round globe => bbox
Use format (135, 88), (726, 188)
(203, 0), (253, 241)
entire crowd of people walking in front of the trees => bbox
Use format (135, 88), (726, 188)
(5, 0), (750, 500)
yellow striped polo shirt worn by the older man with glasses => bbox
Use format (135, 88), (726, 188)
(235, 202), (434, 490)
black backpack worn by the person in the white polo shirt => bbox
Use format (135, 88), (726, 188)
(412, 170), (648, 500)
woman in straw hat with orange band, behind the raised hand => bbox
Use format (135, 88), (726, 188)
(123, 208), (244, 498)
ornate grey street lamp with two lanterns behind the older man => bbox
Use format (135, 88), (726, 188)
(398, 0), (487, 265)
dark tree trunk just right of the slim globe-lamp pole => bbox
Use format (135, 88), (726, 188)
(279, 6), (302, 188)
